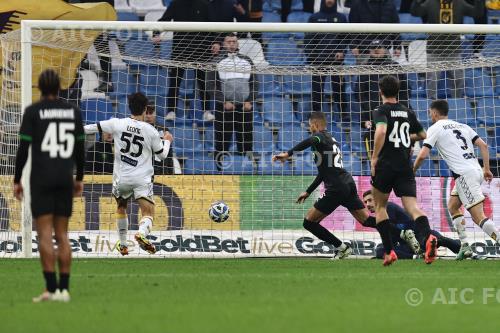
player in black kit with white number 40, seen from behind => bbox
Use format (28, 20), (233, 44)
(371, 75), (437, 266)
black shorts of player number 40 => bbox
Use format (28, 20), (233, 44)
(371, 167), (417, 198)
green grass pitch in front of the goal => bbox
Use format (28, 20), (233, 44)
(0, 258), (500, 333)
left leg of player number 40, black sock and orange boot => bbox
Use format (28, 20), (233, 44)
(372, 186), (398, 266)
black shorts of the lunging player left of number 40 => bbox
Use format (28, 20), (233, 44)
(314, 183), (365, 215)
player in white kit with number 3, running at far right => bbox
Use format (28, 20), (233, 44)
(413, 100), (500, 260)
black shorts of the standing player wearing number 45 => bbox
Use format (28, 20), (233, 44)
(30, 184), (73, 218)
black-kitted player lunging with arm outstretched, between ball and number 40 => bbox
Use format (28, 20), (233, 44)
(273, 112), (375, 259)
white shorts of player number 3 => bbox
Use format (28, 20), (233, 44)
(451, 170), (484, 209)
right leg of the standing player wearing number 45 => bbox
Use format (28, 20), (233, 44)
(54, 216), (71, 302)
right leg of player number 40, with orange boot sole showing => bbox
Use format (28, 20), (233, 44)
(401, 196), (438, 264)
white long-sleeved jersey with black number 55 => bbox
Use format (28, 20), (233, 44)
(84, 118), (170, 186)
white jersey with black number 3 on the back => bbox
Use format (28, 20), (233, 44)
(424, 119), (481, 178)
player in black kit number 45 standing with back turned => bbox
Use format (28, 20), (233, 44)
(14, 69), (85, 302)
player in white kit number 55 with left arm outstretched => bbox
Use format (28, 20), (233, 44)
(84, 93), (173, 255)
